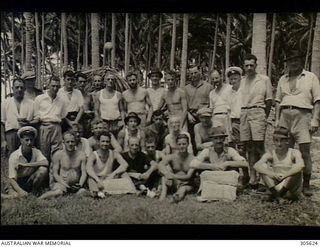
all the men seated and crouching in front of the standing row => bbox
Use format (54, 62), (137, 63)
(2, 110), (304, 202)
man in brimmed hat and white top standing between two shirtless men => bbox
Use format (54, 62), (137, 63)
(147, 68), (165, 110)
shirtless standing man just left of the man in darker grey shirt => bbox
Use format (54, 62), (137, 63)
(157, 71), (188, 131)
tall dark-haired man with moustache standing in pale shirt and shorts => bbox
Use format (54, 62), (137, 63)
(239, 54), (272, 188)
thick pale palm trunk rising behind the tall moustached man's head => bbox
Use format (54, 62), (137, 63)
(252, 13), (267, 74)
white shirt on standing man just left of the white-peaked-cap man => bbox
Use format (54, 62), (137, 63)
(209, 84), (232, 114)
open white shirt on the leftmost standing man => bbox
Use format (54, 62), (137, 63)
(1, 97), (34, 131)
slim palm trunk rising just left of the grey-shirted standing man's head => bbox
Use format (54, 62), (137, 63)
(180, 14), (189, 88)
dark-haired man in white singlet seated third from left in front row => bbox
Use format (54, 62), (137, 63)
(87, 131), (128, 198)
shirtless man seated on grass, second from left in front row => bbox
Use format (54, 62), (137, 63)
(40, 131), (87, 199)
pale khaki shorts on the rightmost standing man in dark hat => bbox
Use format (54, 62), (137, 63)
(279, 109), (312, 144)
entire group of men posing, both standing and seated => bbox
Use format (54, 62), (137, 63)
(1, 50), (320, 202)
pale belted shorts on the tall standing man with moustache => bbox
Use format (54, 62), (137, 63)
(240, 108), (267, 142)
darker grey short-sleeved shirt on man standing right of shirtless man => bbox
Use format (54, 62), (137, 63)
(184, 81), (213, 110)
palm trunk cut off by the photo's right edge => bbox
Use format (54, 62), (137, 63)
(311, 12), (320, 78)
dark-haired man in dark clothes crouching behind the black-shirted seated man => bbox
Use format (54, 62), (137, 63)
(145, 110), (169, 150)
